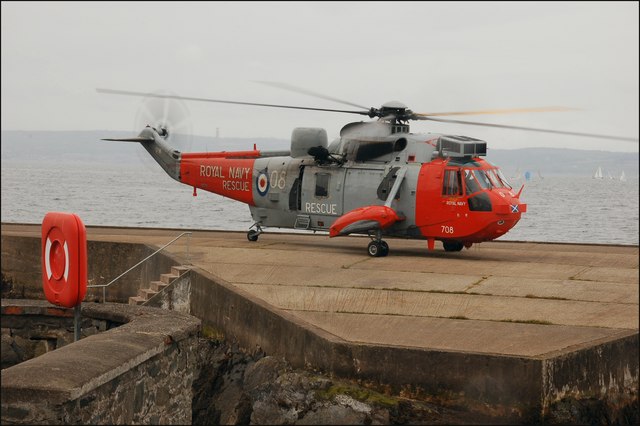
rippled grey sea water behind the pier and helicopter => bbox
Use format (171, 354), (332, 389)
(1, 161), (639, 245)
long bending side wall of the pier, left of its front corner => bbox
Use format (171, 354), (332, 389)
(191, 268), (542, 420)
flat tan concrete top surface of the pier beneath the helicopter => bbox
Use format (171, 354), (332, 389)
(13, 220), (639, 355)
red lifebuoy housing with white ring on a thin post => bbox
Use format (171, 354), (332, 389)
(42, 212), (87, 340)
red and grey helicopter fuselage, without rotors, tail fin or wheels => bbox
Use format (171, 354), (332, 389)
(175, 121), (526, 246)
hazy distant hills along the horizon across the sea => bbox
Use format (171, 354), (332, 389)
(0, 130), (639, 179)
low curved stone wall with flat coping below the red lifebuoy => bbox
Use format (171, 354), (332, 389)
(1, 300), (200, 424)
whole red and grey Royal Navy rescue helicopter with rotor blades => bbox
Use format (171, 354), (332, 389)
(96, 84), (634, 257)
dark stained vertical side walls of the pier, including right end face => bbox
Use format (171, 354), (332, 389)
(3, 233), (639, 422)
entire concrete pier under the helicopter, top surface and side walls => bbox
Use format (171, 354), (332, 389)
(2, 224), (639, 418)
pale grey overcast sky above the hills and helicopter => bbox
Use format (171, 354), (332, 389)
(1, 1), (639, 152)
